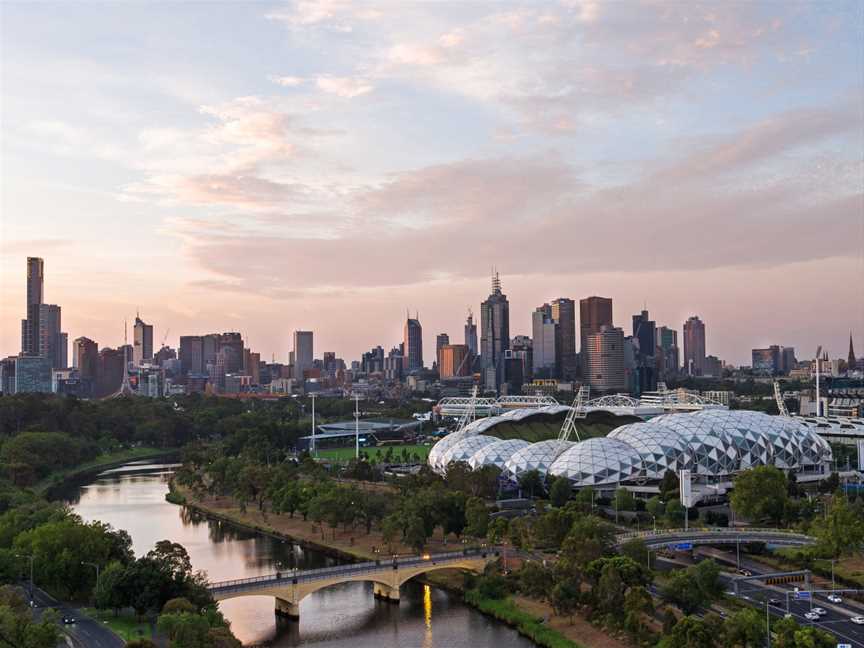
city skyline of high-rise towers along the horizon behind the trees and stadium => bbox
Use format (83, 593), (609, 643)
(0, 257), (860, 398)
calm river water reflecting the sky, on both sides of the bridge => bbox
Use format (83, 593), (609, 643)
(67, 462), (533, 648)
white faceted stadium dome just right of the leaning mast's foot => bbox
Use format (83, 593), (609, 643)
(549, 437), (642, 488)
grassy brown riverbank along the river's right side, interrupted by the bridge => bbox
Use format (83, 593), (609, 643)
(165, 482), (629, 648)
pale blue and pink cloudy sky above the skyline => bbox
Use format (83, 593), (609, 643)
(0, 0), (864, 364)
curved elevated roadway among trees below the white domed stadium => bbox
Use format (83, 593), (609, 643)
(615, 527), (816, 549)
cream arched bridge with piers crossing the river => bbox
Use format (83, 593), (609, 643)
(208, 549), (499, 619)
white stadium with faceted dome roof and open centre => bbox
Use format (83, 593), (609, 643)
(428, 405), (832, 498)
